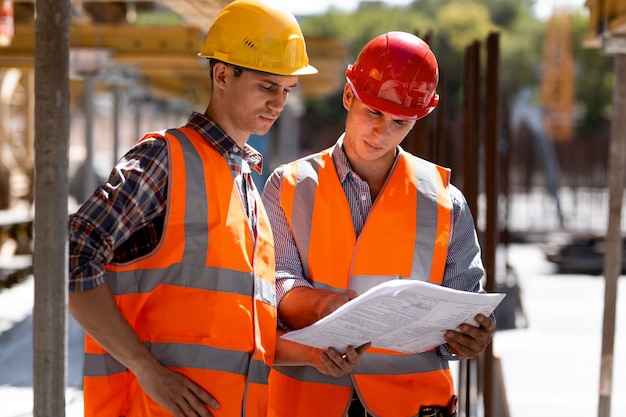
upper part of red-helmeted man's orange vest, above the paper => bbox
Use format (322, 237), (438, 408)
(280, 148), (451, 289)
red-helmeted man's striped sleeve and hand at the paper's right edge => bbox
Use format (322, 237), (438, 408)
(442, 186), (496, 359)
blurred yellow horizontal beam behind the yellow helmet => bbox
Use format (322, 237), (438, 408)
(0, 24), (349, 105)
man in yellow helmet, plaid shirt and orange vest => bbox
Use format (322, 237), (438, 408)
(69, 0), (317, 417)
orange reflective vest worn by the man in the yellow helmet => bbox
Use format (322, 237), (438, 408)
(84, 127), (276, 417)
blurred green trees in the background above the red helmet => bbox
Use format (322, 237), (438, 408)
(301, 0), (612, 136)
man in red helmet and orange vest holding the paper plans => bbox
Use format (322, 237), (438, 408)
(263, 32), (495, 417)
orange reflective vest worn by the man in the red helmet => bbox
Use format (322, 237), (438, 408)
(268, 148), (454, 417)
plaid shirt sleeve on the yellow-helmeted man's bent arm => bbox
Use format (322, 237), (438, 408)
(68, 140), (168, 291)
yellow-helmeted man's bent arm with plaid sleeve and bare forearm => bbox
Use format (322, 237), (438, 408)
(69, 140), (217, 417)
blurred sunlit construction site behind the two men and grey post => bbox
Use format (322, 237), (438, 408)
(0, 0), (626, 417)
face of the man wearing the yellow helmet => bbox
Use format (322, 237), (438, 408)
(210, 64), (298, 144)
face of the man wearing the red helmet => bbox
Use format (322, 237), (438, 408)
(343, 84), (415, 168)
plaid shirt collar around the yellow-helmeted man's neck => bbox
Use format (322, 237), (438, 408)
(187, 112), (263, 174)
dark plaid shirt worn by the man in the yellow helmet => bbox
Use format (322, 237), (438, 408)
(69, 112), (262, 291)
